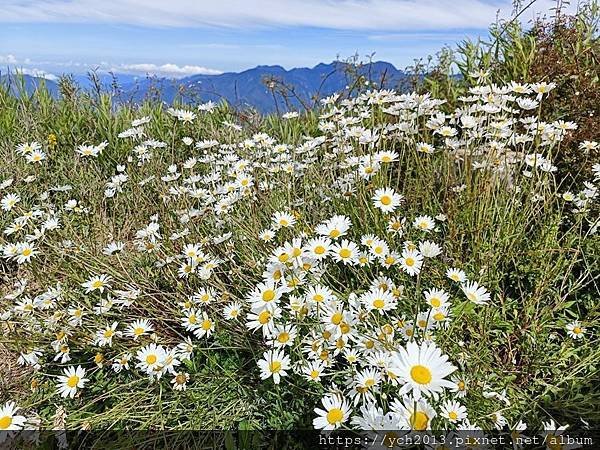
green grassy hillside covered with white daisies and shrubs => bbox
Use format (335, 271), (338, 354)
(0, 4), (600, 446)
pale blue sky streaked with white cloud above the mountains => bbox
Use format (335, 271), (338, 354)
(0, 0), (572, 78)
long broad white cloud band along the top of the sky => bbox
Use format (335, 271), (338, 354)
(0, 0), (576, 31)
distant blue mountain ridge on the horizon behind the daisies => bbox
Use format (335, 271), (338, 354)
(0, 61), (405, 113)
